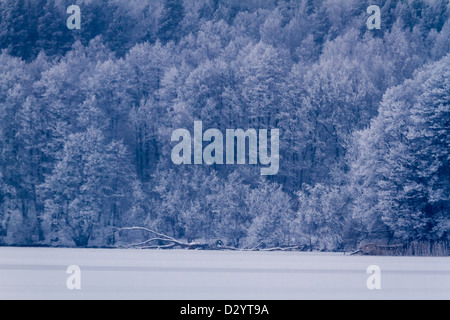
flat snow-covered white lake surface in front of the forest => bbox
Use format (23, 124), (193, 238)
(0, 247), (450, 300)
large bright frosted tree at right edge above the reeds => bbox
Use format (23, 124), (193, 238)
(352, 55), (450, 241)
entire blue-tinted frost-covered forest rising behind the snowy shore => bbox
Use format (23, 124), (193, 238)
(0, 0), (450, 250)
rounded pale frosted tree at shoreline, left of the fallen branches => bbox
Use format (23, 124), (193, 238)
(42, 128), (133, 246)
